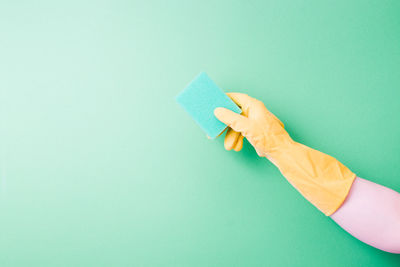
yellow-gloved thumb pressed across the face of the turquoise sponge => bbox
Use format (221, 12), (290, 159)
(214, 108), (250, 136)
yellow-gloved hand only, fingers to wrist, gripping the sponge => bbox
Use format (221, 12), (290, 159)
(214, 93), (292, 157)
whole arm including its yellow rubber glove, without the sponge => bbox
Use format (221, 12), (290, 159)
(214, 93), (400, 253)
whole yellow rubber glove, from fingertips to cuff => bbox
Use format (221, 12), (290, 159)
(214, 93), (356, 216)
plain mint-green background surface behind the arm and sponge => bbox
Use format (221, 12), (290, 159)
(0, 0), (400, 266)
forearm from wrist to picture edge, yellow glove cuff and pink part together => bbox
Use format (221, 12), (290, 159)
(268, 142), (400, 253)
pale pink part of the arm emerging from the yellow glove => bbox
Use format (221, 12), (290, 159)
(331, 177), (400, 253)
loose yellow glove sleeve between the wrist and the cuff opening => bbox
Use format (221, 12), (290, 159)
(267, 141), (355, 216)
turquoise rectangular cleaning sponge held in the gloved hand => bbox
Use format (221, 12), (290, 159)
(176, 72), (241, 138)
